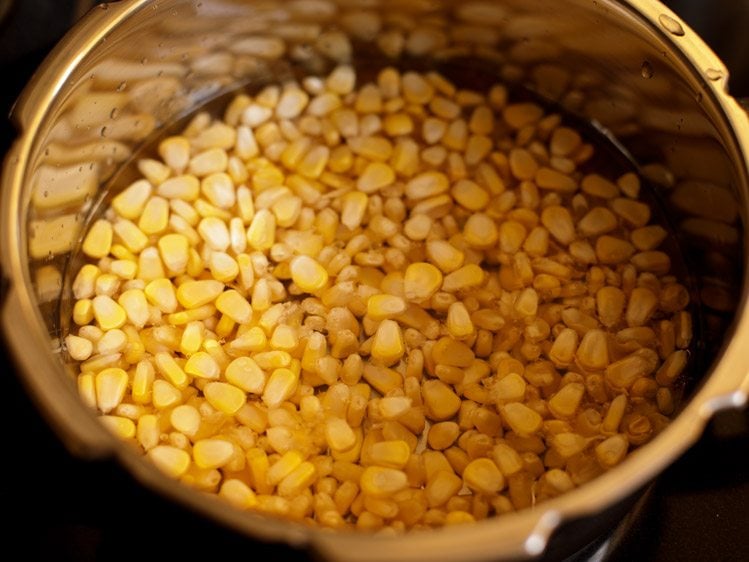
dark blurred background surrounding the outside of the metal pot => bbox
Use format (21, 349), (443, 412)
(0, 0), (749, 562)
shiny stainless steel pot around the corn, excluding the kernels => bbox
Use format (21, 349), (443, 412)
(0, 0), (749, 561)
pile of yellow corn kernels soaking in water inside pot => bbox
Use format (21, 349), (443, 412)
(65, 66), (691, 532)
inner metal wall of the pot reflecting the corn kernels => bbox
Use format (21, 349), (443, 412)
(10, 0), (747, 552)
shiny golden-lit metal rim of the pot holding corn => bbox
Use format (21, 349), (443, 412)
(0, 0), (749, 560)
